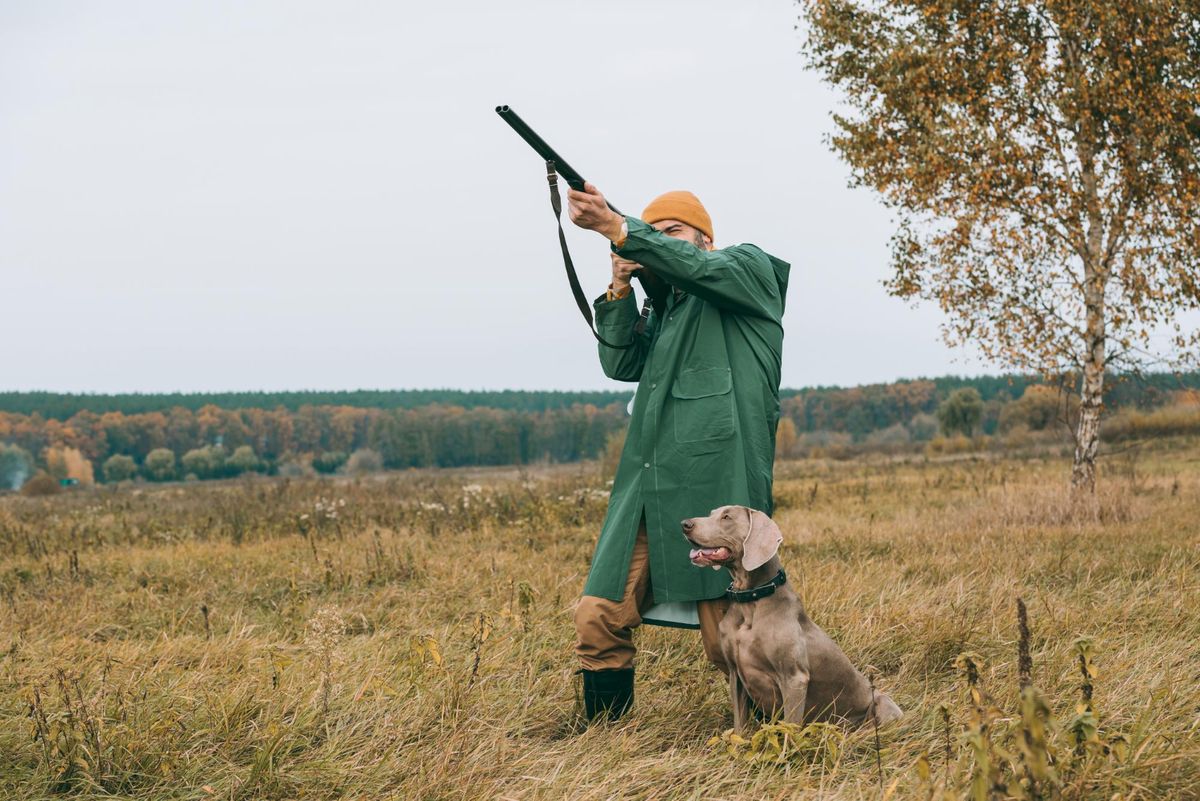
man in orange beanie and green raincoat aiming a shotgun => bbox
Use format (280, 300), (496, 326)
(568, 183), (788, 719)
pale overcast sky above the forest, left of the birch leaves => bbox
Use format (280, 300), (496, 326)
(0, 0), (989, 392)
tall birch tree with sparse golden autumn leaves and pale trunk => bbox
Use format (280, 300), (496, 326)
(802, 0), (1200, 489)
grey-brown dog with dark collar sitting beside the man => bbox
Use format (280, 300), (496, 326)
(683, 506), (902, 731)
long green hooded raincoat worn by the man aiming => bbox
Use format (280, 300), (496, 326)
(583, 217), (788, 604)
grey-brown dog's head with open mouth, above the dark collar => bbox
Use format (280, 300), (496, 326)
(682, 506), (784, 573)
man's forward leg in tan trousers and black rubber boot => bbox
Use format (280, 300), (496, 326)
(575, 518), (650, 721)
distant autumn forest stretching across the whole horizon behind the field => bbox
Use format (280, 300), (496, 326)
(0, 373), (1200, 486)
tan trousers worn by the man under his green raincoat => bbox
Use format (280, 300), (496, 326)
(575, 519), (730, 674)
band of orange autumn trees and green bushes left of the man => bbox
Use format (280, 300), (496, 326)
(0, 403), (625, 480)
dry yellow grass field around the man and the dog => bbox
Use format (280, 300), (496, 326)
(0, 441), (1200, 800)
